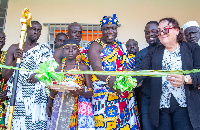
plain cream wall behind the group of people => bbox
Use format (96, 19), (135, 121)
(4, 0), (200, 50)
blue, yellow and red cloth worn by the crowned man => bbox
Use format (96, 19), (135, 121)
(82, 39), (140, 130)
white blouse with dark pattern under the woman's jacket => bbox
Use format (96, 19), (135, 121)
(160, 47), (187, 108)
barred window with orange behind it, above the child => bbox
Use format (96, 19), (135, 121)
(43, 23), (102, 50)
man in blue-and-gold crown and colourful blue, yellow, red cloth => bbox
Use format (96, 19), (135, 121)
(82, 14), (140, 130)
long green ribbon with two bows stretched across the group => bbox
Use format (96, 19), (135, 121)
(0, 60), (200, 92)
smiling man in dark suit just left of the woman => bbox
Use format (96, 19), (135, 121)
(135, 21), (160, 130)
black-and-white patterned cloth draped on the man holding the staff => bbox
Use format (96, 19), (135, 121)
(6, 44), (53, 130)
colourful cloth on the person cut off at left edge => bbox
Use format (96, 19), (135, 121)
(0, 51), (8, 130)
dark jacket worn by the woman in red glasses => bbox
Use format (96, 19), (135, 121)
(136, 43), (200, 128)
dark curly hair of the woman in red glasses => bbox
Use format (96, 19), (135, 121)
(159, 18), (184, 43)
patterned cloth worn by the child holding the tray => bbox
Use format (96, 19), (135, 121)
(49, 58), (94, 130)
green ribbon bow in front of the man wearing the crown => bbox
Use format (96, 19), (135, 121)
(113, 75), (137, 92)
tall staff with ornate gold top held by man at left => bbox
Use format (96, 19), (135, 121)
(7, 8), (32, 130)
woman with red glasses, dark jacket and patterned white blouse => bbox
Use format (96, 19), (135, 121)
(136, 18), (200, 130)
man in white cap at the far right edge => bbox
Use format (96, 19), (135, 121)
(183, 21), (200, 43)
